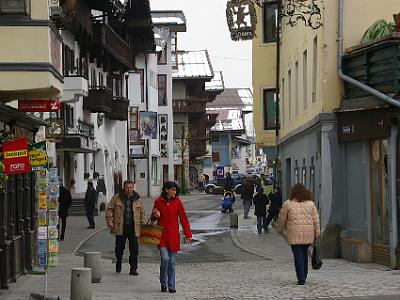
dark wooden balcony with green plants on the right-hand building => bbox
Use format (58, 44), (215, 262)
(343, 32), (400, 100)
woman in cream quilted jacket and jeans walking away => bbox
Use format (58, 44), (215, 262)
(277, 183), (320, 285)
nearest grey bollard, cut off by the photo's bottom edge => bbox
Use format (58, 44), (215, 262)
(71, 268), (92, 300)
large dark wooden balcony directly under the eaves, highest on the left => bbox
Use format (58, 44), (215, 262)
(91, 22), (134, 69)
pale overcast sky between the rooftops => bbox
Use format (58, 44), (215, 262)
(150, 0), (252, 88)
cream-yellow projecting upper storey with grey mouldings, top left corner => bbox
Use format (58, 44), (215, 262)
(0, 0), (63, 102)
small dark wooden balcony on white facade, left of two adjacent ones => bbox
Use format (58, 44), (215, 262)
(83, 86), (113, 113)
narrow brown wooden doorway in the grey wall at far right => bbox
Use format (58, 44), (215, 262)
(370, 140), (390, 266)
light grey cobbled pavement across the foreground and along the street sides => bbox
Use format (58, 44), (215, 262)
(0, 199), (400, 300)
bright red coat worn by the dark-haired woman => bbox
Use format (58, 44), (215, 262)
(153, 197), (192, 251)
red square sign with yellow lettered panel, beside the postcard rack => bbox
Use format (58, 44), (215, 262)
(3, 138), (30, 174)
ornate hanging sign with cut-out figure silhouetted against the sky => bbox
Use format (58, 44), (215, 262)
(226, 0), (257, 41)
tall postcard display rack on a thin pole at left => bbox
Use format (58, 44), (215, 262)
(35, 168), (59, 294)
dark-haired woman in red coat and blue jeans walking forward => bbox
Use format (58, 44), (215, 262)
(152, 181), (192, 293)
